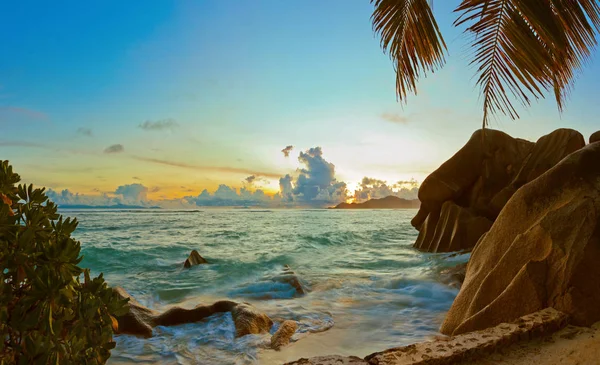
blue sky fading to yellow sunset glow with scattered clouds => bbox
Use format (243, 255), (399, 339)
(0, 0), (600, 207)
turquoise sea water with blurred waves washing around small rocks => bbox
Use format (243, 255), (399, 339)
(63, 209), (467, 364)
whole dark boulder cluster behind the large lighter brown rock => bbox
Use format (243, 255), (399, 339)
(411, 129), (585, 252)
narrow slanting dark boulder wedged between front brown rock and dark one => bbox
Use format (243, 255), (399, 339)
(490, 129), (585, 215)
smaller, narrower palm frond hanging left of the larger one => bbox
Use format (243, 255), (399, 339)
(371, 0), (446, 100)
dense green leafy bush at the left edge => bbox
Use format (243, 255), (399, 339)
(0, 161), (127, 365)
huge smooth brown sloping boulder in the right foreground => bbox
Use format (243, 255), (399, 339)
(441, 143), (600, 335)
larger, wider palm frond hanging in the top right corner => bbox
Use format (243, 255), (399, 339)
(455, 0), (600, 128)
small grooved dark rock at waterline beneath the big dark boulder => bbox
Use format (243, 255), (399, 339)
(414, 201), (492, 252)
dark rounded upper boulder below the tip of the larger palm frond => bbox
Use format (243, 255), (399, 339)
(416, 129), (533, 215)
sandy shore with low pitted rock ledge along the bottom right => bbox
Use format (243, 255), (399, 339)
(284, 308), (600, 365)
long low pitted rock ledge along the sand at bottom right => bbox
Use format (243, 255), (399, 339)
(366, 308), (567, 365)
